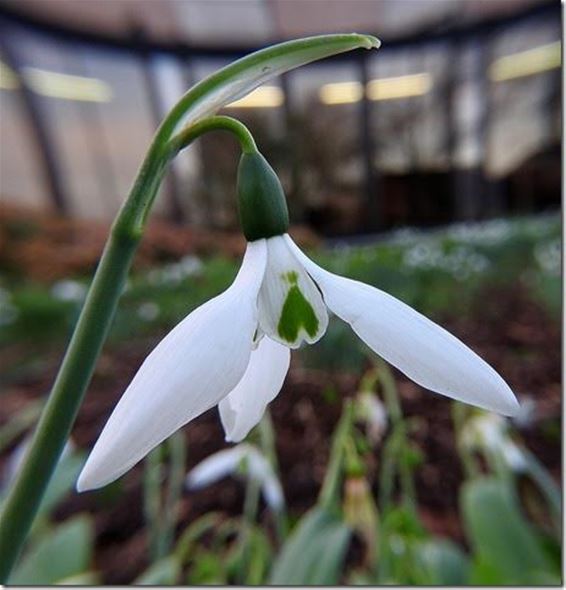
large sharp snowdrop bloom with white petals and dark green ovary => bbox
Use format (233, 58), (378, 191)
(77, 152), (517, 491)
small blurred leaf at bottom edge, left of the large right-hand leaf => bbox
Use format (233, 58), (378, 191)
(417, 539), (470, 586)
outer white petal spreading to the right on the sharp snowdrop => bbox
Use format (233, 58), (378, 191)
(285, 235), (519, 415)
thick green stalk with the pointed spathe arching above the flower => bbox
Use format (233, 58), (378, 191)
(0, 34), (379, 583)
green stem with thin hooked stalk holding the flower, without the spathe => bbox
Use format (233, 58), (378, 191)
(0, 117), (255, 583)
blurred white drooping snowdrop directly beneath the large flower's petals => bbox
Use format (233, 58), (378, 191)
(186, 443), (285, 511)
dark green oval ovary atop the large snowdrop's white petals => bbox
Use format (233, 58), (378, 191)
(238, 152), (289, 242)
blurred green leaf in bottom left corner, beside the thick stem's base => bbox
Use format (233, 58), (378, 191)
(9, 516), (93, 586)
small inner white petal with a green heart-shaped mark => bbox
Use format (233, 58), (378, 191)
(258, 236), (328, 348)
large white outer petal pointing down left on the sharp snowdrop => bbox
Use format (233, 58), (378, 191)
(77, 240), (267, 491)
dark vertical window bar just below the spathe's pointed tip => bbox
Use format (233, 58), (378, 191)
(358, 54), (382, 232)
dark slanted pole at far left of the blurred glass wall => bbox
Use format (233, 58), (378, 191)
(0, 30), (70, 215)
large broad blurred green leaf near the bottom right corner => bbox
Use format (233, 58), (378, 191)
(462, 477), (551, 585)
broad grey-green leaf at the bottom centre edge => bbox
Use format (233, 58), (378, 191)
(268, 508), (350, 586)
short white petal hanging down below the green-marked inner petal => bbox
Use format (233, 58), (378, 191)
(218, 337), (291, 442)
